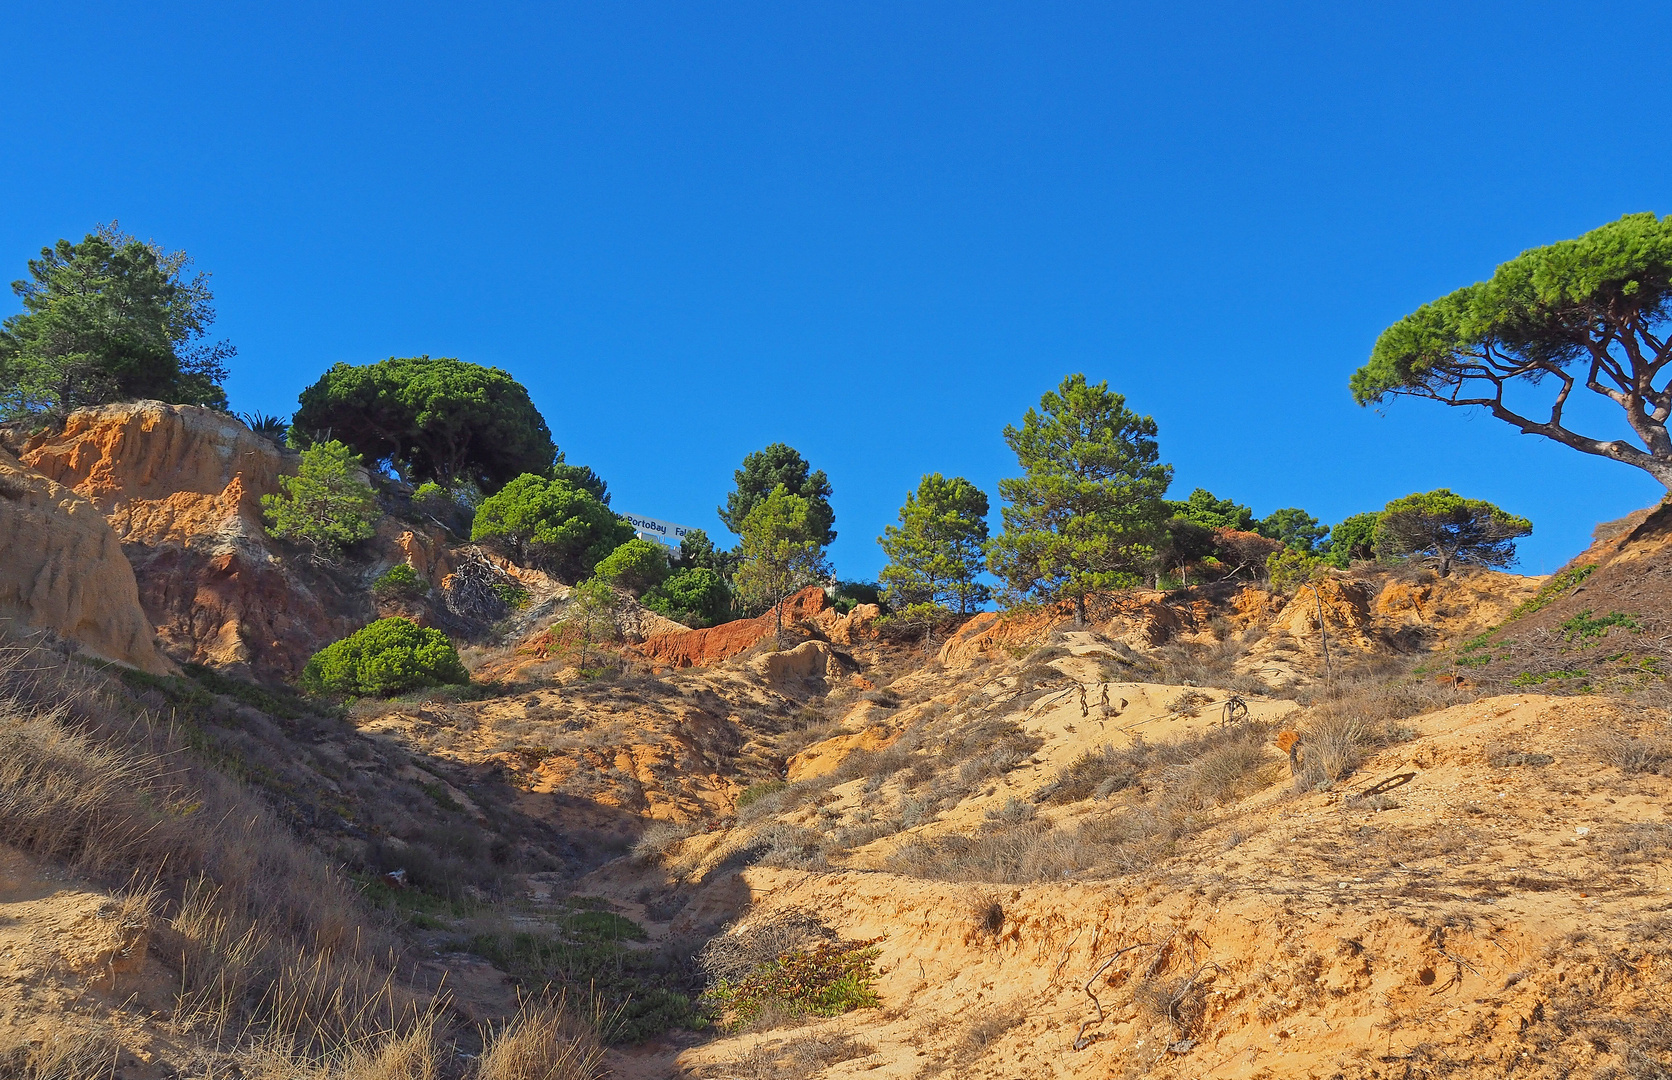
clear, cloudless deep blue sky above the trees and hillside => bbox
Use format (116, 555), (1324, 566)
(0, 2), (1672, 577)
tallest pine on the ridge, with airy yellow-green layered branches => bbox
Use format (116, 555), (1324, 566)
(988, 374), (1172, 624)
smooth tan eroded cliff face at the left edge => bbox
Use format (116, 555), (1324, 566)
(0, 450), (174, 674)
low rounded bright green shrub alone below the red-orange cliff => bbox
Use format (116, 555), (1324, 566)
(301, 617), (470, 697)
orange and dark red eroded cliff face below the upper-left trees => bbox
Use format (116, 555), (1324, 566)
(18, 401), (373, 675)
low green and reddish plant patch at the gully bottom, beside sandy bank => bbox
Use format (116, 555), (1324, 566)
(704, 938), (881, 1030)
